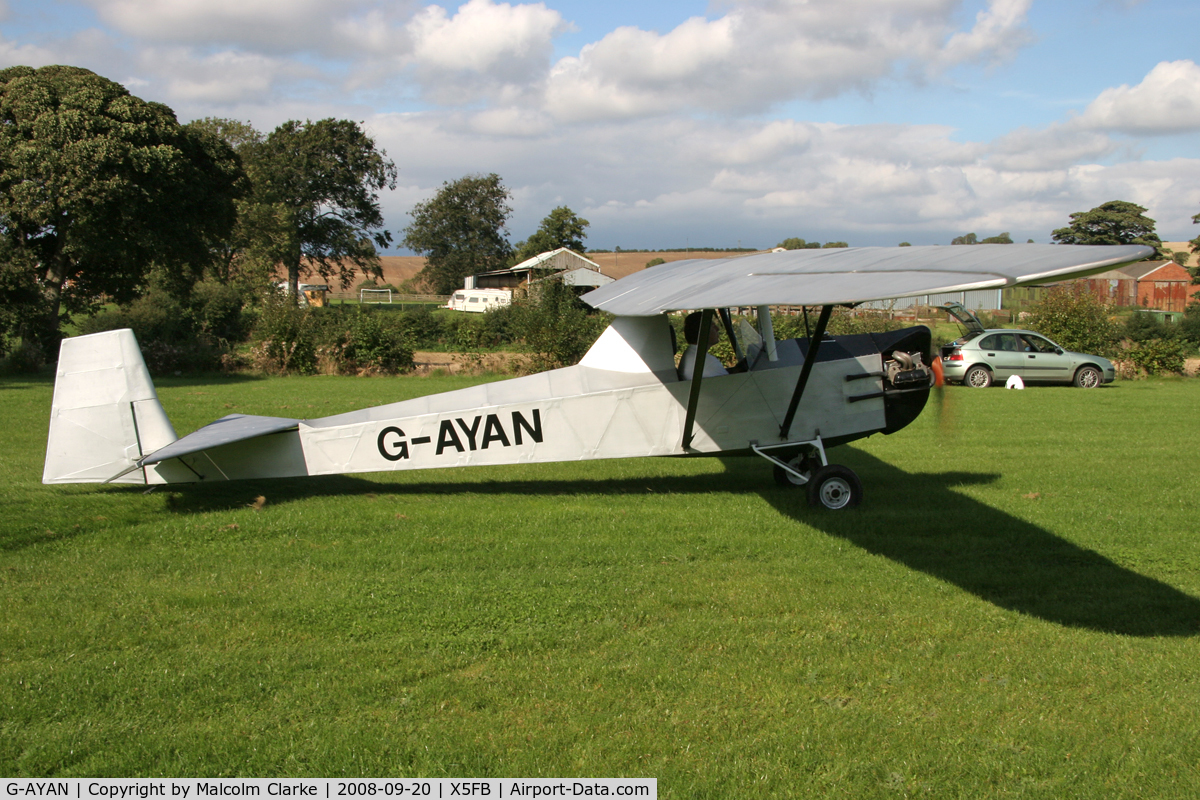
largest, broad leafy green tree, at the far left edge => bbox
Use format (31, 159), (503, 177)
(0, 66), (242, 344)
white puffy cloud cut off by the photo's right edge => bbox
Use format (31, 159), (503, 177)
(1078, 60), (1200, 134)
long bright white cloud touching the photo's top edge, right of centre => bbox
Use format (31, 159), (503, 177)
(546, 0), (1030, 121)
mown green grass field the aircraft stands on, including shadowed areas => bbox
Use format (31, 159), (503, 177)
(0, 369), (1200, 799)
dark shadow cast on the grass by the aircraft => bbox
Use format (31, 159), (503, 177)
(98, 447), (1200, 637)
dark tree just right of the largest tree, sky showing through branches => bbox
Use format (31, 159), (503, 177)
(244, 119), (396, 296)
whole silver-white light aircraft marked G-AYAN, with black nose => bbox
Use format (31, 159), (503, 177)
(42, 245), (1153, 509)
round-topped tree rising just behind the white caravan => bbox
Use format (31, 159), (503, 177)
(403, 173), (512, 294)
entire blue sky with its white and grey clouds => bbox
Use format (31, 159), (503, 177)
(0, 0), (1200, 254)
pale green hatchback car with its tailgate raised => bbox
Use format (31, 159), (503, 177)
(942, 303), (1116, 389)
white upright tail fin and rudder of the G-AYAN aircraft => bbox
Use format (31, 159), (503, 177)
(42, 329), (179, 483)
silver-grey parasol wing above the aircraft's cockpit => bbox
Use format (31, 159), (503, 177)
(583, 245), (1154, 317)
